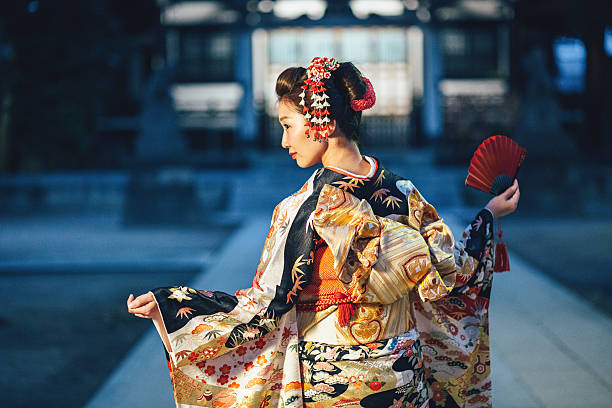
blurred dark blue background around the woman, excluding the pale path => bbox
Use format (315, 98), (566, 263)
(0, 0), (612, 407)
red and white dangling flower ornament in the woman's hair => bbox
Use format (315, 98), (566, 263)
(300, 57), (340, 142)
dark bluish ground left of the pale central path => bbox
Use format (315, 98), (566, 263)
(0, 214), (231, 408)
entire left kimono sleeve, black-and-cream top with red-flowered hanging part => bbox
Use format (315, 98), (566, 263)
(152, 178), (316, 408)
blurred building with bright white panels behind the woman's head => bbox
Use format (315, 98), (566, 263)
(152, 0), (512, 155)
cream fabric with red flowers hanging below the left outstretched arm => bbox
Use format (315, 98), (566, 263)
(169, 313), (302, 407)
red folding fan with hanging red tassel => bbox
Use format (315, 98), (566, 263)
(465, 135), (527, 272)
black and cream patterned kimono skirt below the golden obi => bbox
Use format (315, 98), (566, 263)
(300, 331), (429, 408)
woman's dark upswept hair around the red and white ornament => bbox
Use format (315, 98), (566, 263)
(276, 62), (367, 141)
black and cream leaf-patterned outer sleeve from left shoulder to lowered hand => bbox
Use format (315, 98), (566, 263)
(152, 171), (317, 367)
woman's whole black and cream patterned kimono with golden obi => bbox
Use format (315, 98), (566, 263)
(152, 157), (493, 408)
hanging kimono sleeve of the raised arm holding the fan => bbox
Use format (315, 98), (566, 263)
(414, 210), (494, 408)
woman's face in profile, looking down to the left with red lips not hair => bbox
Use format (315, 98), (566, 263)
(278, 100), (327, 167)
